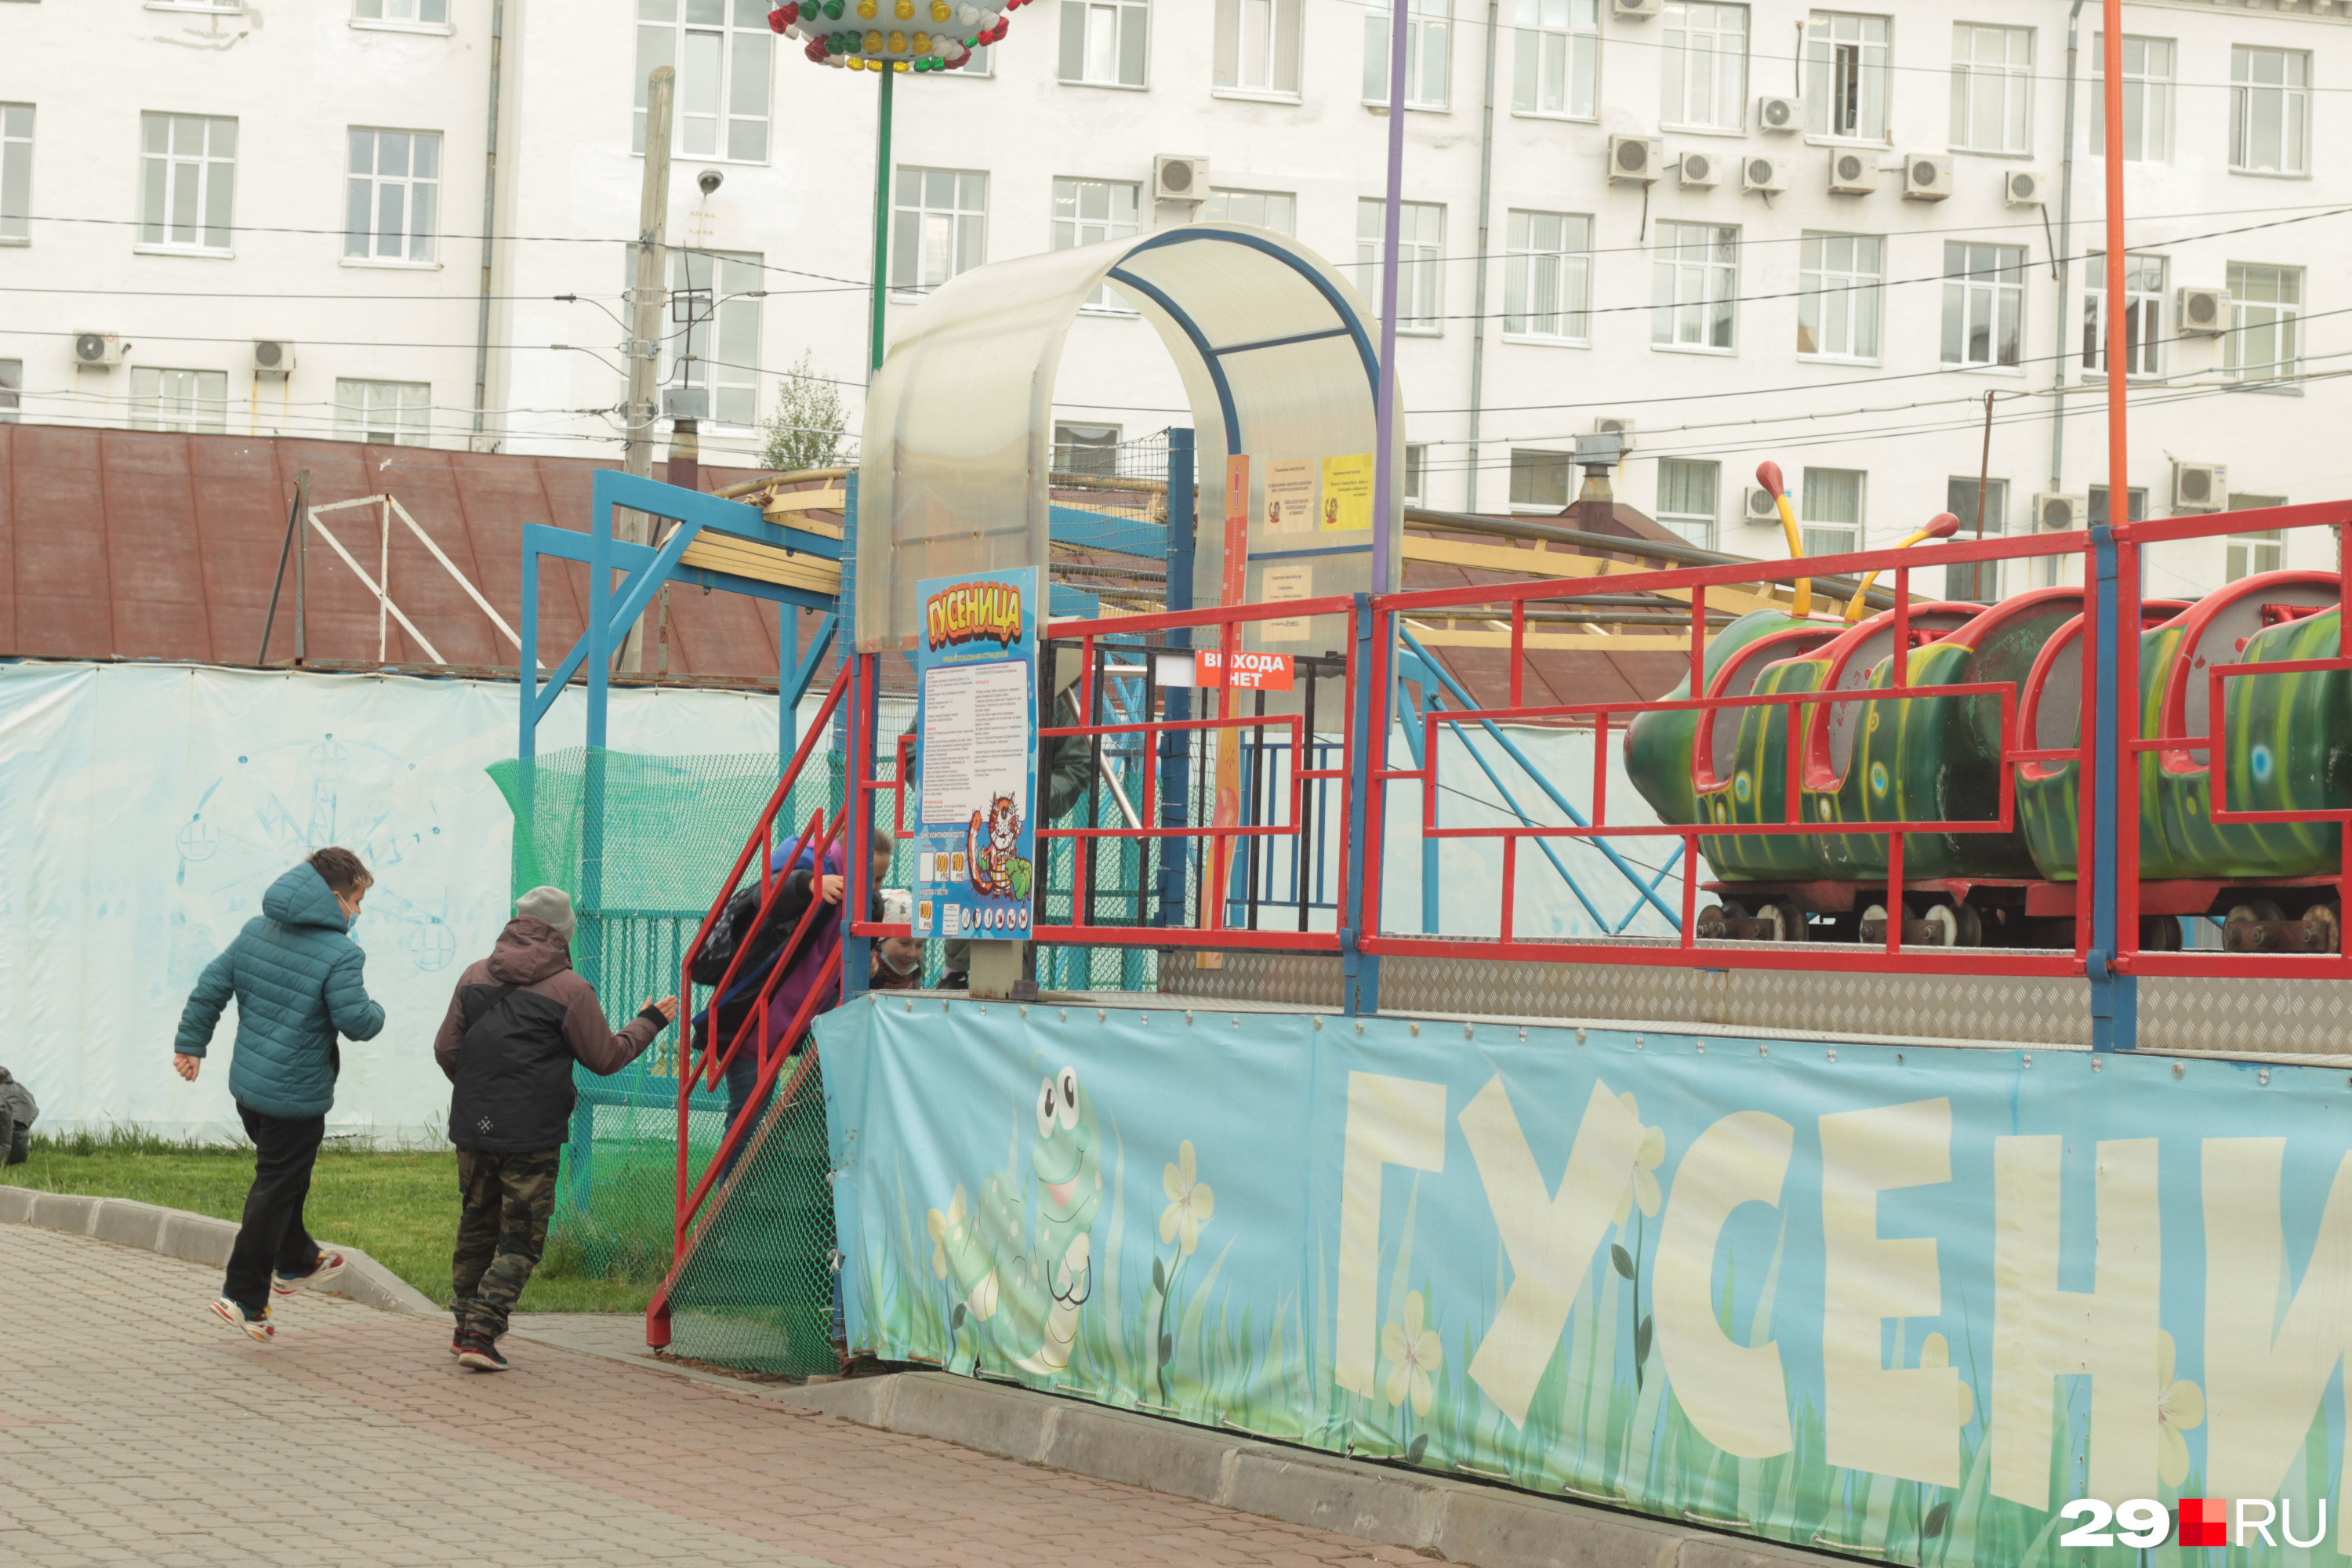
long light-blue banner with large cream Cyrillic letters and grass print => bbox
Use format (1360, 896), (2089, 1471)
(818, 994), (2352, 1568)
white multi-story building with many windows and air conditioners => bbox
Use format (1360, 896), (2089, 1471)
(0, 0), (2352, 595)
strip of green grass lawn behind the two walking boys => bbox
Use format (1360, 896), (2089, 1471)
(0, 1131), (652, 1312)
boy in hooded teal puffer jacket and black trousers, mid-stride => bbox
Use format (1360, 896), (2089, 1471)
(172, 848), (383, 1340)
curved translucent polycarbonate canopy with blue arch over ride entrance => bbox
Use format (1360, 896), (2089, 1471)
(856, 223), (1404, 654)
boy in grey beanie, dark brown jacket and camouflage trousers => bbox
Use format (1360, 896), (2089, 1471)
(433, 886), (677, 1373)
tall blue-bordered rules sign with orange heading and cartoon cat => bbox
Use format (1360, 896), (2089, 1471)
(915, 567), (1040, 940)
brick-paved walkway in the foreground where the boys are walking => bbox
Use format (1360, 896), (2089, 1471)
(0, 1225), (1421, 1568)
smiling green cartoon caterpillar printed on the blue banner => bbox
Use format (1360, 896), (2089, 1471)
(929, 1067), (1103, 1375)
